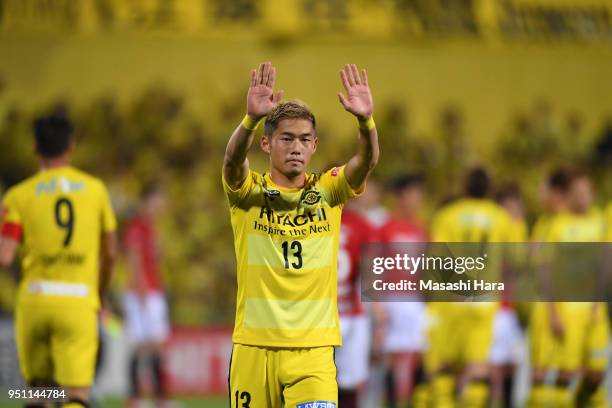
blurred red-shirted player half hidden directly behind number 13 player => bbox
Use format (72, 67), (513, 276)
(335, 197), (376, 408)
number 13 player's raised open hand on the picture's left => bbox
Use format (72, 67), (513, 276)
(247, 62), (283, 120)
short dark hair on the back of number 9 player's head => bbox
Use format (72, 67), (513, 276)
(33, 115), (74, 157)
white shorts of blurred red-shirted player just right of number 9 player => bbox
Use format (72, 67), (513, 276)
(124, 292), (170, 344)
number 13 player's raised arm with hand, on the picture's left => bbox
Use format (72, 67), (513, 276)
(223, 62), (282, 188)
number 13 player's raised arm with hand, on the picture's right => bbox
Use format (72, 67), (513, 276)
(338, 64), (379, 189)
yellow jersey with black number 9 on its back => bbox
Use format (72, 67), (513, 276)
(2, 166), (117, 308)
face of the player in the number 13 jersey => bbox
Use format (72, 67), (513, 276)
(261, 119), (318, 178)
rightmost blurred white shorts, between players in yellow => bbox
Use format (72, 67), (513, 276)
(489, 309), (522, 365)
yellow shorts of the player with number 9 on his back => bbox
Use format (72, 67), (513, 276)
(15, 304), (98, 387)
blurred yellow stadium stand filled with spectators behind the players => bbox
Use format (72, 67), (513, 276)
(0, 0), (612, 325)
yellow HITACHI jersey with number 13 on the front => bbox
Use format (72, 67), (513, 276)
(223, 167), (363, 347)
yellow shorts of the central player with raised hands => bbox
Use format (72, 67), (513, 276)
(229, 344), (338, 408)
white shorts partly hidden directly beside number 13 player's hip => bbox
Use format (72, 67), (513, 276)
(335, 315), (371, 389)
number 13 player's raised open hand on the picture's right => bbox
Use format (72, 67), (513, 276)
(338, 64), (374, 120)
